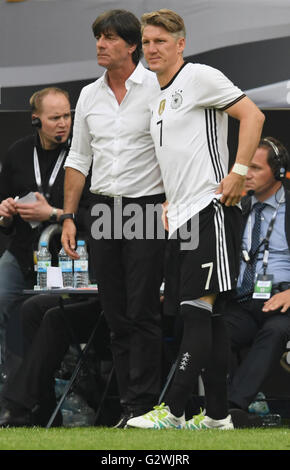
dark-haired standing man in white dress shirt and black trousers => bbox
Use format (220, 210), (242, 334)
(62, 10), (165, 427)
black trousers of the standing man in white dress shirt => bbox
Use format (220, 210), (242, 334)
(91, 195), (165, 409)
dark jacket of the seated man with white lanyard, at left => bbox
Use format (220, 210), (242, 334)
(0, 135), (88, 277)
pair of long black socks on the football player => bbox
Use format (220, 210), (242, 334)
(164, 300), (229, 419)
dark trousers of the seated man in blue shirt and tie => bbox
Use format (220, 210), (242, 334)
(224, 300), (290, 410)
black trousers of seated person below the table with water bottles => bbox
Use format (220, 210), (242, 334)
(3, 295), (103, 425)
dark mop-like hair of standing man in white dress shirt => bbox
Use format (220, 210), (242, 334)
(92, 10), (142, 65)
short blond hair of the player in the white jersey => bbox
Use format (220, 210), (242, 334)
(141, 8), (186, 39)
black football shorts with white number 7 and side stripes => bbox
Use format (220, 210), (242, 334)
(178, 199), (242, 301)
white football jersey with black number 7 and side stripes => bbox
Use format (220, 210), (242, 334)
(151, 63), (245, 236)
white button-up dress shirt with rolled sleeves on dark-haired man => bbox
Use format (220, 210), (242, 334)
(65, 63), (164, 197)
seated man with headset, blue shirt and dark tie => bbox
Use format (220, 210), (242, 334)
(224, 137), (290, 426)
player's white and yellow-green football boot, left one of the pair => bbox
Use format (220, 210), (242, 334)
(127, 403), (185, 429)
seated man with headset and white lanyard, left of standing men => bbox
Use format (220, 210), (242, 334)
(0, 87), (82, 374)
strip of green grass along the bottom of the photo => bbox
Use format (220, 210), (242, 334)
(0, 427), (290, 451)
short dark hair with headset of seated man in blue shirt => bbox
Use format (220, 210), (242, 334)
(258, 137), (290, 178)
